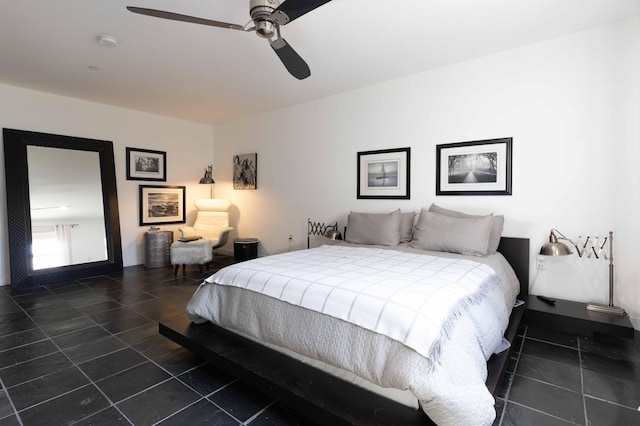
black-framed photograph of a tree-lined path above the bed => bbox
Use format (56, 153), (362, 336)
(436, 138), (513, 195)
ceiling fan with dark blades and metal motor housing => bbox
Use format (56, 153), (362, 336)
(127, 0), (331, 80)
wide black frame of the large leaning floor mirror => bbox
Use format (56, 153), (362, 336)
(3, 129), (123, 289)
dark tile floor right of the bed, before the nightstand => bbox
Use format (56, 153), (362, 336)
(495, 320), (640, 426)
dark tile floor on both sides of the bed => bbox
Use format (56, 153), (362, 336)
(0, 256), (640, 426)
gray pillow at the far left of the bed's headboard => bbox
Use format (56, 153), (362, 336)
(345, 209), (400, 246)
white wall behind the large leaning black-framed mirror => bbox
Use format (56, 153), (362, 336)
(0, 84), (213, 285)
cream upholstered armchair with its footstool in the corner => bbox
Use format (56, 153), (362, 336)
(171, 199), (233, 275)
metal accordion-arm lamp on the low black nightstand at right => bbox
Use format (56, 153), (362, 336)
(540, 229), (624, 315)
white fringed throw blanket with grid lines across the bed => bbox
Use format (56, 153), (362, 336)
(206, 246), (498, 362)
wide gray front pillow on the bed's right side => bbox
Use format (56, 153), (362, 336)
(409, 209), (492, 256)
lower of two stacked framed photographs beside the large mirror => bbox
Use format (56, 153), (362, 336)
(140, 185), (186, 226)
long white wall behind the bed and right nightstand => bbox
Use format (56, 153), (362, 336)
(214, 18), (640, 328)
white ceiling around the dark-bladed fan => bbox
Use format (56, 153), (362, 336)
(0, 0), (640, 124)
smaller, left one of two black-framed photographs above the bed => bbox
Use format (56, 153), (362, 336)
(357, 148), (411, 200)
